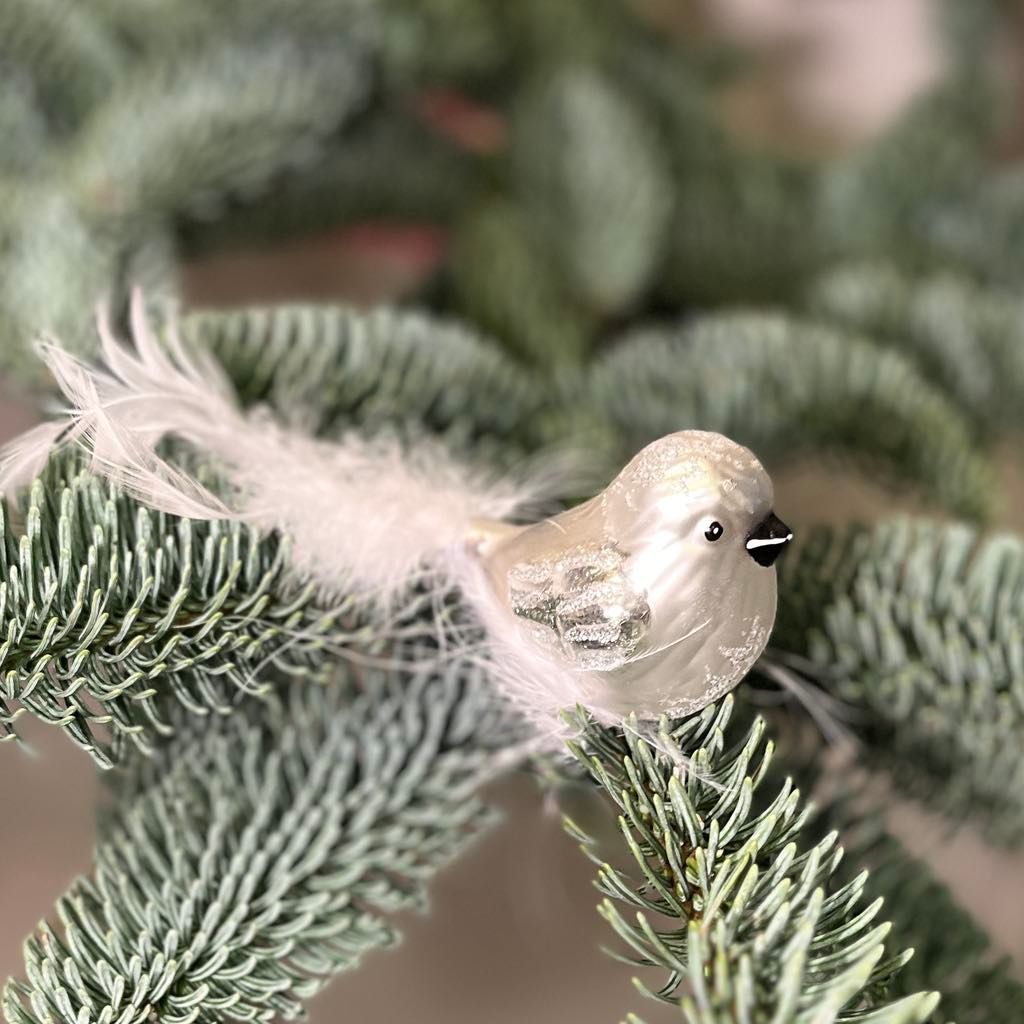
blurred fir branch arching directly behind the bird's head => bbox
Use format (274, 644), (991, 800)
(583, 312), (994, 518)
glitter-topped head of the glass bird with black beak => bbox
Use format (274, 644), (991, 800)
(603, 430), (793, 575)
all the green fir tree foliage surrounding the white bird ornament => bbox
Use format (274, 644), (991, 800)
(0, 0), (1024, 1024)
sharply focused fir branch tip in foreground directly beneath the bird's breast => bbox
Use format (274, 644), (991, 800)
(568, 697), (938, 1024)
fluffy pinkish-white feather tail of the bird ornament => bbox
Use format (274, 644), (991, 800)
(0, 294), (564, 604)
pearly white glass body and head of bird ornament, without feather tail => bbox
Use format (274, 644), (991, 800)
(479, 431), (788, 719)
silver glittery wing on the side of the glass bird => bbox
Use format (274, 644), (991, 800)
(508, 545), (650, 672)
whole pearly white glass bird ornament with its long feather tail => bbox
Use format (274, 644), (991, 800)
(0, 296), (792, 737)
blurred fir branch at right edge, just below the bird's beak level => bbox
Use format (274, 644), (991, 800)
(772, 520), (1024, 842)
